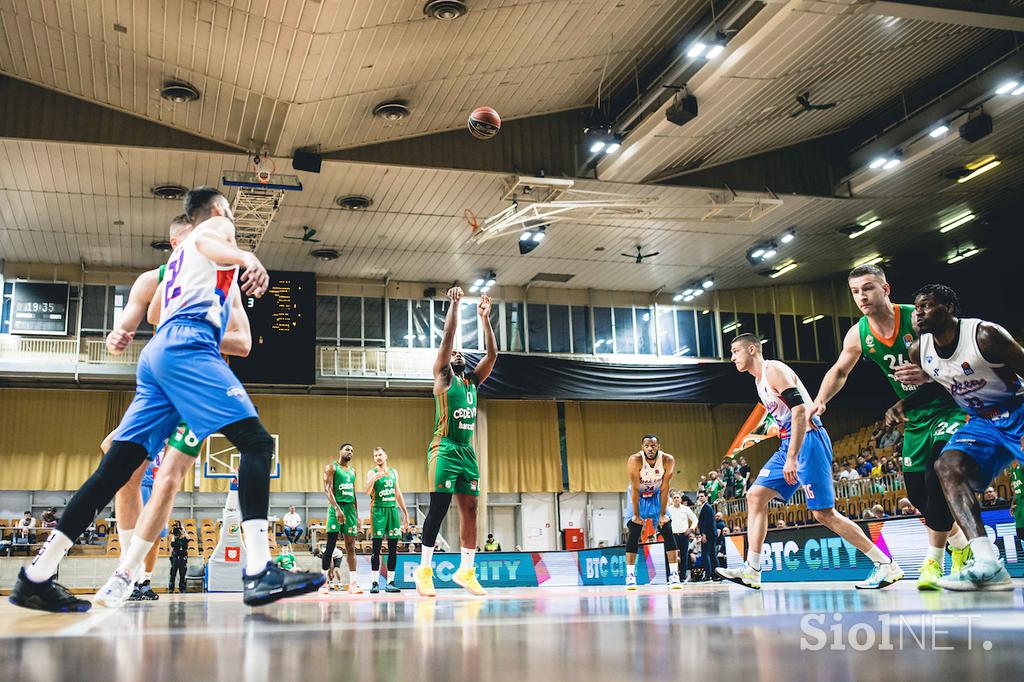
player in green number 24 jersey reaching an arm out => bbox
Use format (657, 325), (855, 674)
(809, 265), (970, 590)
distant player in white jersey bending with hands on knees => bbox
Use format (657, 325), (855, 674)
(626, 434), (682, 590)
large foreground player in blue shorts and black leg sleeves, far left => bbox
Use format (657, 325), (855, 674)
(11, 186), (324, 611)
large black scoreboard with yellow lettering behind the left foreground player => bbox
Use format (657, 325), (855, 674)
(228, 271), (316, 385)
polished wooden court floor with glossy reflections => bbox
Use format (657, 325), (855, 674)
(0, 582), (1024, 682)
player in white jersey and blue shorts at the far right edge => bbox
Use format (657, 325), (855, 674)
(886, 285), (1024, 591)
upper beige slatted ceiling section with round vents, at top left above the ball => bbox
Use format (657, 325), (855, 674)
(0, 0), (705, 156)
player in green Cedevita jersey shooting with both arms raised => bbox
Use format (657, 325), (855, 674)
(416, 287), (498, 597)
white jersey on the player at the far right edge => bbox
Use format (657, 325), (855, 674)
(921, 318), (1024, 415)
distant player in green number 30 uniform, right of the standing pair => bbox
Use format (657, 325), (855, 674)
(367, 447), (409, 594)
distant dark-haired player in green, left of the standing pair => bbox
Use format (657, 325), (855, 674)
(321, 442), (362, 594)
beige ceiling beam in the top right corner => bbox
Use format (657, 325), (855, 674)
(859, 0), (1024, 31)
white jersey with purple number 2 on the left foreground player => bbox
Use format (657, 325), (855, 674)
(157, 222), (239, 335)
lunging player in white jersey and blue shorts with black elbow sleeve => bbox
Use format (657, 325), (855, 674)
(716, 334), (903, 590)
